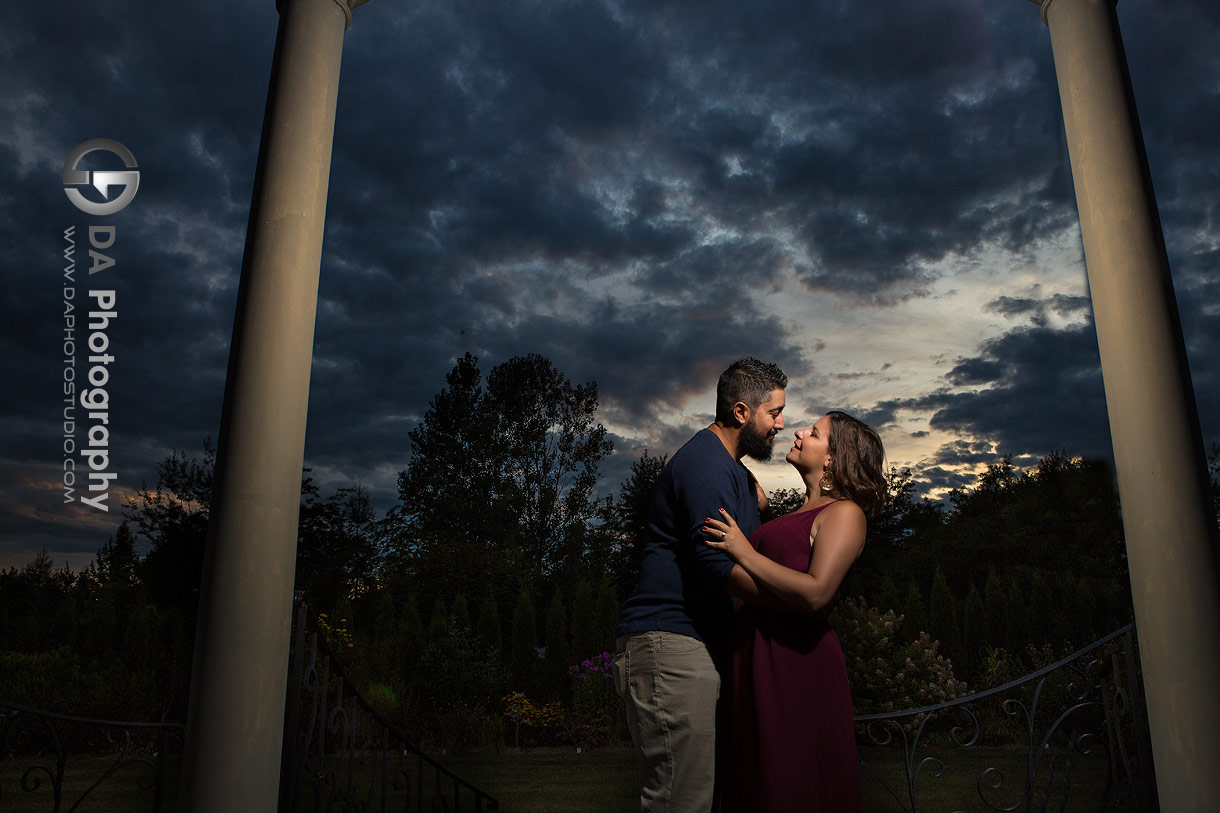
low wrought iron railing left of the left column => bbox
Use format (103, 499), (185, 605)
(0, 701), (185, 813)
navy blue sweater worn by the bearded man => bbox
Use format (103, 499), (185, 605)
(615, 430), (760, 658)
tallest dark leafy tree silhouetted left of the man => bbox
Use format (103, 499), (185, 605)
(387, 353), (611, 602)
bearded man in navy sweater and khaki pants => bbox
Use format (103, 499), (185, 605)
(614, 359), (788, 813)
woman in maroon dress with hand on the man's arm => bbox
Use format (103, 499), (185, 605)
(704, 411), (886, 813)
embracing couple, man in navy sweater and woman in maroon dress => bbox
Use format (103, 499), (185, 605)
(615, 359), (886, 813)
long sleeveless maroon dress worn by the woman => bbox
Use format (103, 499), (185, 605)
(725, 505), (860, 813)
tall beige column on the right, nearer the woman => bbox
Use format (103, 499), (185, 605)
(1035, 0), (1220, 800)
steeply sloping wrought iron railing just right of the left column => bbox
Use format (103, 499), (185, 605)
(279, 601), (499, 813)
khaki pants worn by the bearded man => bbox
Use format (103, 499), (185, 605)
(614, 631), (720, 813)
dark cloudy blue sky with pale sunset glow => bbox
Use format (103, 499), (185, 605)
(0, 0), (1220, 568)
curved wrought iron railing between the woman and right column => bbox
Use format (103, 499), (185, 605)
(855, 625), (1157, 813)
